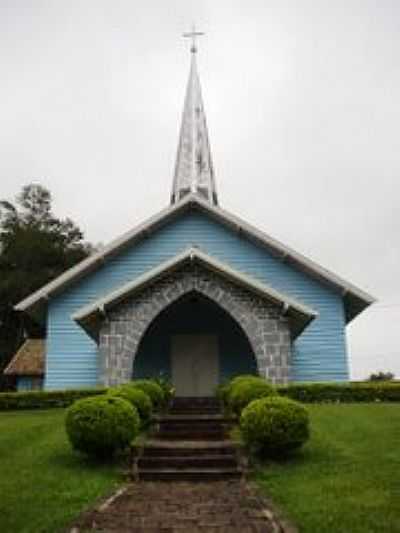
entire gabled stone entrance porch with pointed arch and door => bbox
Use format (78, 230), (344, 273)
(73, 248), (316, 388)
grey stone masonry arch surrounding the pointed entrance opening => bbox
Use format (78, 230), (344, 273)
(99, 264), (291, 385)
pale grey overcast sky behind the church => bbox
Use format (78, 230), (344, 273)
(0, 0), (400, 378)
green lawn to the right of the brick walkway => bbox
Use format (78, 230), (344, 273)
(255, 404), (400, 533)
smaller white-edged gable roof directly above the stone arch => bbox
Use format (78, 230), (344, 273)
(72, 248), (318, 338)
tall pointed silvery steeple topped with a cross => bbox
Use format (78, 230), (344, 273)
(171, 28), (218, 205)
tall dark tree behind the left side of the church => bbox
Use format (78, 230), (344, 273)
(0, 184), (93, 373)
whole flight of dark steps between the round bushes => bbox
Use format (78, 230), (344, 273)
(132, 398), (242, 481)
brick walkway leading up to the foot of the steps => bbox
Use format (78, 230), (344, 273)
(72, 480), (293, 533)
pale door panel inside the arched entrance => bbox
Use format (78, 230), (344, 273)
(171, 335), (219, 396)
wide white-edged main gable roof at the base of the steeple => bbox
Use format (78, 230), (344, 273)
(15, 195), (375, 322)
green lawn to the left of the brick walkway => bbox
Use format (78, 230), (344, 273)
(0, 409), (121, 533)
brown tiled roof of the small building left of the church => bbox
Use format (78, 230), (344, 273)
(4, 339), (46, 376)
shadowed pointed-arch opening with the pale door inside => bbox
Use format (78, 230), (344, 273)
(133, 291), (257, 396)
